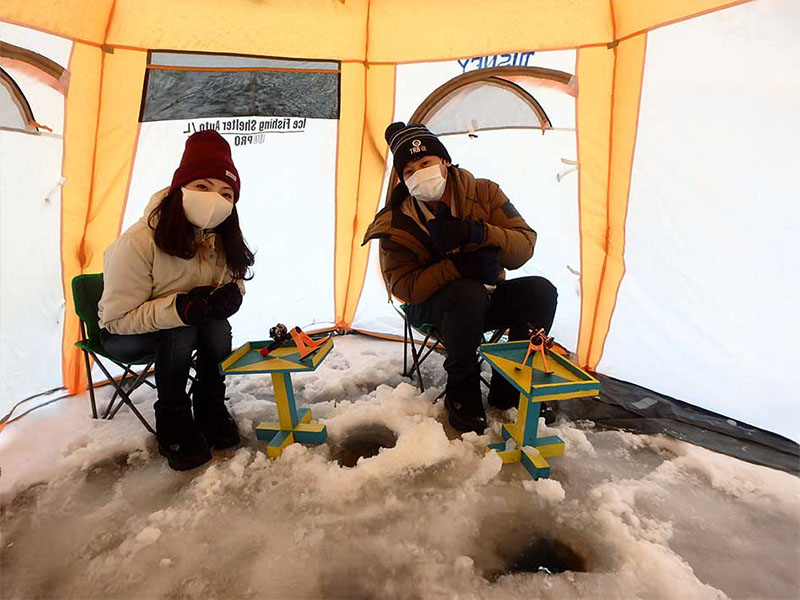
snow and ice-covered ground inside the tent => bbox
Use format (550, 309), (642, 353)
(0, 336), (800, 599)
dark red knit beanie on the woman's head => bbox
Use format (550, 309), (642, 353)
(169, 129), (239, 202)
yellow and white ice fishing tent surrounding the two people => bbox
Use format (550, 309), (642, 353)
(0, 0), (800, 440)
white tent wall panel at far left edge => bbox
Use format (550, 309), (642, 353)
(0, 23), (72, 407)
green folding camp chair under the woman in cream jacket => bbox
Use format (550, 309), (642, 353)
(72, 273), (156, 434)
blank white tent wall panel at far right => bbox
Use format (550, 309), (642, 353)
(598, 0), (800, 439)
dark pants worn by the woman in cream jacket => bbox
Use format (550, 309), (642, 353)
(102, 319), (231, 413)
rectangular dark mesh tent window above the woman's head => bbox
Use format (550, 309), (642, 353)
(140, 52), (340, 122)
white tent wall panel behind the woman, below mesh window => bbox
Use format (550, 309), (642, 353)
(123, 117), (337, 344)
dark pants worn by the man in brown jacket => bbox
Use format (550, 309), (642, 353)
(406, 277), (558, 382)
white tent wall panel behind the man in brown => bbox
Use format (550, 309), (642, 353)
(353, 52), (580, 348)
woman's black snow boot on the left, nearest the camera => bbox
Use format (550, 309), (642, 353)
(155, 398), (211, 471)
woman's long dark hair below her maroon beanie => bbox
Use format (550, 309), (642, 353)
(147, 188), (255, 280)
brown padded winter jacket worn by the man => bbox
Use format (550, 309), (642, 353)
(362, 166), (536, 304)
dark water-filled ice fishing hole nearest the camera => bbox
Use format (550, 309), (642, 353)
(486, 536), (586, 581)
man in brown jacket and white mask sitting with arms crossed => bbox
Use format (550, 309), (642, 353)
(364, 123), (557, 433)
